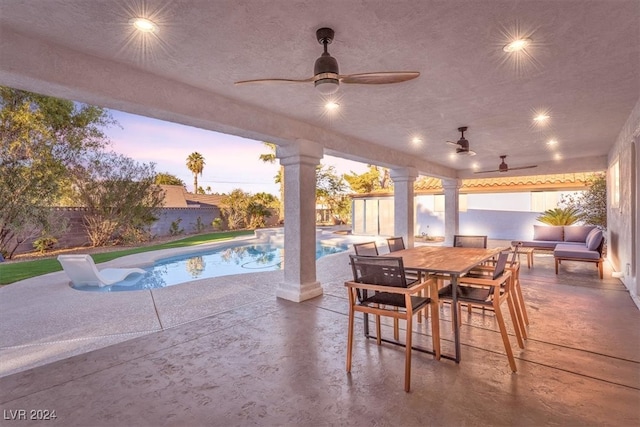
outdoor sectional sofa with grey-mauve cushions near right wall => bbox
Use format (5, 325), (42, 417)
(512, 225), (604, 279)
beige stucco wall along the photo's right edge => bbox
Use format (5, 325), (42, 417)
(607, 99), (640, 303)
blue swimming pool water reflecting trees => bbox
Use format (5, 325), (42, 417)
(73, 243), (347, 292)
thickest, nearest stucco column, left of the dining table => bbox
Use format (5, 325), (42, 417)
(276, 140), (323, 302)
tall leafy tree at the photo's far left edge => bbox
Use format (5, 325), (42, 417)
(0, 86), (116, 257)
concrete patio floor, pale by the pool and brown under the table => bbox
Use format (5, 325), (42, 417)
(0, 242), (640, 426)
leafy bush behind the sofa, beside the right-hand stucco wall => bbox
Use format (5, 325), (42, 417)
(561, 174), (607, 229)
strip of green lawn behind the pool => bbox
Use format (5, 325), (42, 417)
(0, 230), (253, 285)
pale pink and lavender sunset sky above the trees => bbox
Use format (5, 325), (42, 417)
(107, 110), (367, 196)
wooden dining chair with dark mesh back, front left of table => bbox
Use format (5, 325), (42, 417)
(345, 255), (440, 392)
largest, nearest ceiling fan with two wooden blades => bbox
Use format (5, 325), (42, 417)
(235, 28), (420, 95)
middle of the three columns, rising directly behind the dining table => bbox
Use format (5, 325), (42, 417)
(391, 168), (418, 248)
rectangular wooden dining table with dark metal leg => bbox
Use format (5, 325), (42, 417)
(387, 246), (504, 363)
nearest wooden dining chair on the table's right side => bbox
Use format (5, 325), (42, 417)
(438, 252), (524, 372)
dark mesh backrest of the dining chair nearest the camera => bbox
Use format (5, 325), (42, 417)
(349, 255), (407, 288)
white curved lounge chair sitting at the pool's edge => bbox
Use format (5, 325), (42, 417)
(58, 255), (146, 287)
